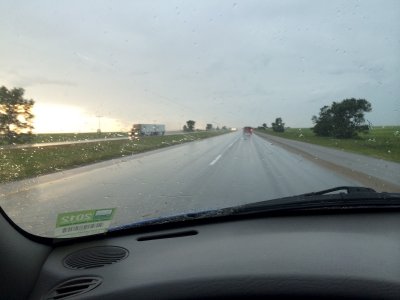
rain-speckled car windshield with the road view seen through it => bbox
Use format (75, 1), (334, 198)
(0, 0), (400, 238)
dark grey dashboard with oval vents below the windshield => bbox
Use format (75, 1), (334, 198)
(0, 207), (400, 299)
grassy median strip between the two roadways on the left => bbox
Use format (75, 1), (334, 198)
(0, 130), (227, 182)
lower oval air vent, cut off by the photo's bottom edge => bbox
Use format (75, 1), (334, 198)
(46, 277), (102, 300)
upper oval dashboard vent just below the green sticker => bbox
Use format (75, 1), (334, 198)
(64, 246), (129, 270)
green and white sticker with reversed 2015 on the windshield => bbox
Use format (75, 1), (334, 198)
(54, 208), (116, 237)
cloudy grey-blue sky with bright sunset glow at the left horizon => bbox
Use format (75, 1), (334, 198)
(0, 0), (400, 132)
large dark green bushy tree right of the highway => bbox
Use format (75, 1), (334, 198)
(312, 98), (372, 138)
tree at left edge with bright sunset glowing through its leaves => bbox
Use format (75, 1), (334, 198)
(0, 86), (35, 144)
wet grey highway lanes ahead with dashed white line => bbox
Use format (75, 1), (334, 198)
(0, 132), (400, 236)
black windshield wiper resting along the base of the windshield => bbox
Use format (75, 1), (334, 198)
(109, 186), (400, 232)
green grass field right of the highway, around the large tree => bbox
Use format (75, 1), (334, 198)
(257, 126), (400, 162)
